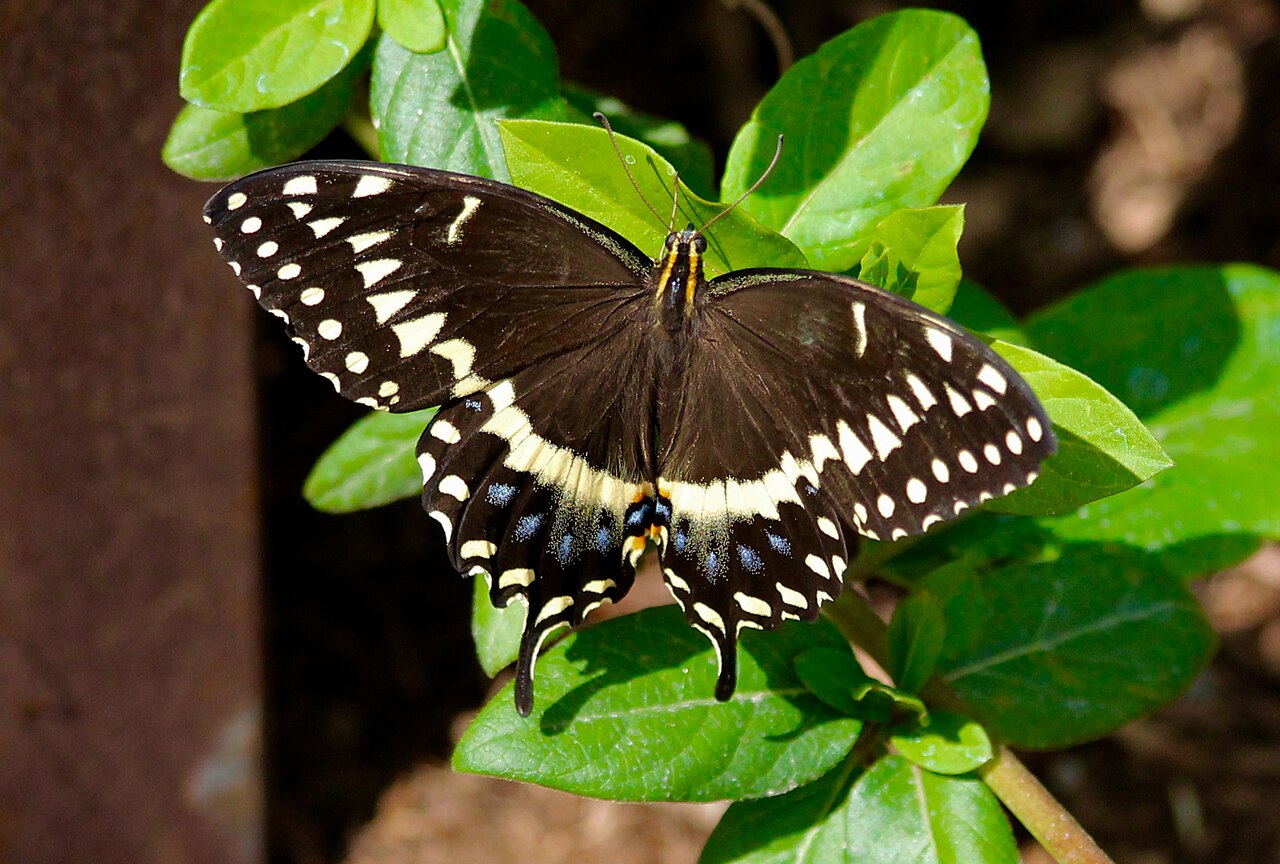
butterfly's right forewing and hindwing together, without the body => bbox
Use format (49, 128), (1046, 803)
(658, 270), (1056, 698)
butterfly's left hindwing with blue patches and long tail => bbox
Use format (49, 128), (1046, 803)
(417, 311), (657, 713)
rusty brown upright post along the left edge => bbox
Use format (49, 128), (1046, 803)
(0, 0), (261, 864)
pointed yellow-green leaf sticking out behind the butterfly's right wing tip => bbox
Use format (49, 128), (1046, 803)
(987, 340), (1172, 516)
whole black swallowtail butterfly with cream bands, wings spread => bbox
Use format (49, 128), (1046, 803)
(205, 161), (1056, 714)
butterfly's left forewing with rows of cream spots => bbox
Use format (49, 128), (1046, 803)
(205, 161), (652, 411)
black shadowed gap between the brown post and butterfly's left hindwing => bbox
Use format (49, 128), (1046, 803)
(259, 311), (486, 861)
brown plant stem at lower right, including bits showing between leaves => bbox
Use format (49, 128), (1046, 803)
(822, 590), (1114, 864)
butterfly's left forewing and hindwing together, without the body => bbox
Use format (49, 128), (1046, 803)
(205, 163), (657, 713)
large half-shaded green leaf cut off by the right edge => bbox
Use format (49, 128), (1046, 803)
(1028, 265), (1280, 555)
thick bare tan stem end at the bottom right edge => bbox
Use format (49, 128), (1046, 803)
(978, 746), (1114, 864)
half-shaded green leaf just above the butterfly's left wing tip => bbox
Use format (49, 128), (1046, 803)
(161, 43), (371, 180)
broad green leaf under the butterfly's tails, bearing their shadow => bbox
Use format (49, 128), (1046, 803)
(453, 607), (861, 801)
